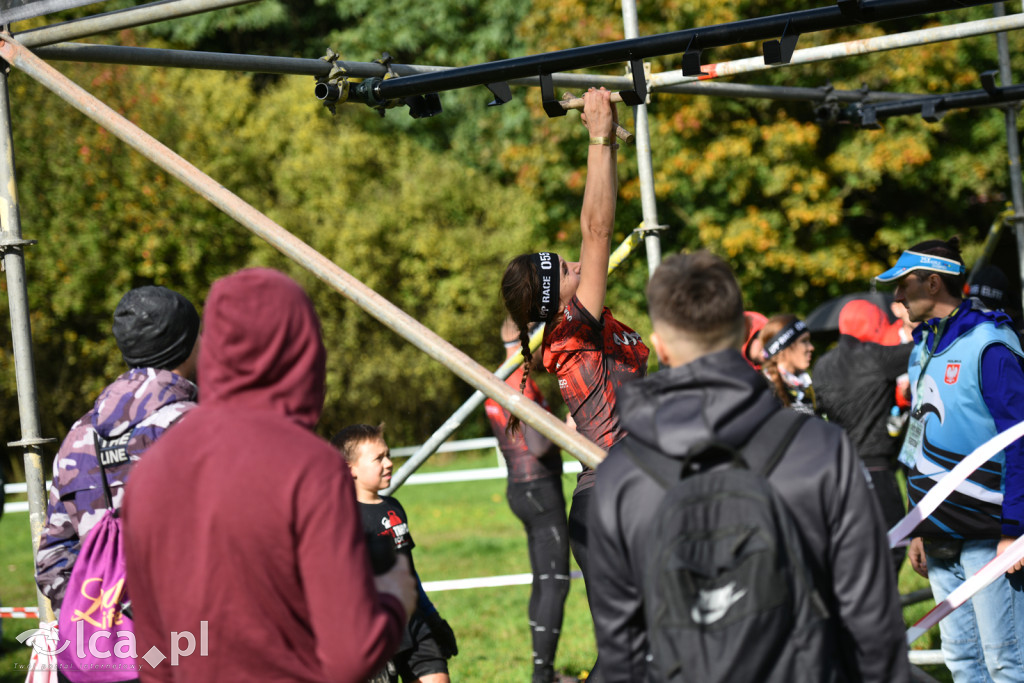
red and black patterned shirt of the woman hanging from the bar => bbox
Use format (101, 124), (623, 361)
(544, 297), (650, 490)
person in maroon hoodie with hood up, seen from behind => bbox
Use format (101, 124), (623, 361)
(124, 268), (416, 683)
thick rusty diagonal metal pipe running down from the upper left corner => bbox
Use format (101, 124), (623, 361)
(0, 34), (605, 467)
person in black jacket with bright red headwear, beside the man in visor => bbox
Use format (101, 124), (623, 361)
(811, 301), (913, 573)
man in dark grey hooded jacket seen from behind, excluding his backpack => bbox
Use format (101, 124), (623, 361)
(590, 252), (909, 683)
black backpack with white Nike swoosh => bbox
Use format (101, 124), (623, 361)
(624, 410), (841, 683)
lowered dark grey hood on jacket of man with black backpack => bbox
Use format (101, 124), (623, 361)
(618, 349), (781, 457)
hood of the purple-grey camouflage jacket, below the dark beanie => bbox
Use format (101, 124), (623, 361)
(92, 368), (196, 439)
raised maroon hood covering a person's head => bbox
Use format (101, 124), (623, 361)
(199, 268), (327, 429)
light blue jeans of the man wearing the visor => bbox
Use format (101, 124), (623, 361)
(928, 540), (1024, 683)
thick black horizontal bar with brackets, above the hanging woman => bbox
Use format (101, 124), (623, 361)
(375, 0), (993, 100)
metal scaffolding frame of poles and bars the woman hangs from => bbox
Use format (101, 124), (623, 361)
(0, 0), (1024, 621)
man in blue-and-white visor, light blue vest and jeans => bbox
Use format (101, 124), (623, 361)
(876, 238), (1024, 683)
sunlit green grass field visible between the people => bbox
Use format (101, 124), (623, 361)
(0, 452), (951, 683)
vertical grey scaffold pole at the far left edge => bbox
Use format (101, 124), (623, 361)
(0, 68), (53, 622)
